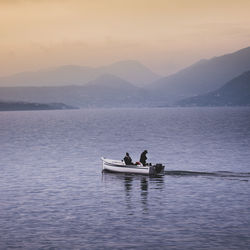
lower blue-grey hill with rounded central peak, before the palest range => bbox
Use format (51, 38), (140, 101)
(0, 74), (148, 107)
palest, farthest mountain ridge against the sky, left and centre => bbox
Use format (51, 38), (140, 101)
(0, 61), (160, 87)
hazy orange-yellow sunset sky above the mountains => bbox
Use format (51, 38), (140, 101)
(0, 0), (250, 76)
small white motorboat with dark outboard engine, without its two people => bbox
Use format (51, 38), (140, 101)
(101, 157), (165, 175)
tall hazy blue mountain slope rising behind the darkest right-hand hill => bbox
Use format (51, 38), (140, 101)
(147, 47), (250, 103)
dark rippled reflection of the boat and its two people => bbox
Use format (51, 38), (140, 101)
(102, 172), (164, 214)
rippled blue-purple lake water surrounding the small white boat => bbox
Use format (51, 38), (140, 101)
(0, 108), (250, 249)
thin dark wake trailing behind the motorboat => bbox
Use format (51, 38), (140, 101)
(165, 170), (250, 181)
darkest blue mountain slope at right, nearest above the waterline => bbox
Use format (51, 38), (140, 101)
(178, 71), (250, 106)
